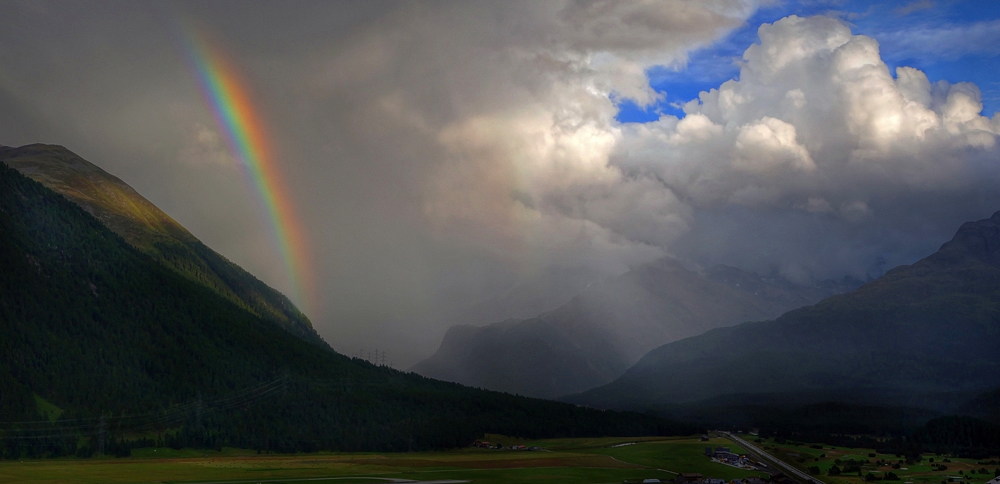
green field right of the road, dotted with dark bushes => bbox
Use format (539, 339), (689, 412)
(758, 439), (1000, 484)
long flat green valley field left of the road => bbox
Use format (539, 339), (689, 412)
(0, 435), (772, 484)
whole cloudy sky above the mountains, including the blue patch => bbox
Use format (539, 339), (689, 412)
(0, 0), (1000, 368)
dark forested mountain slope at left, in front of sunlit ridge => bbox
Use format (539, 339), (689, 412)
(0, 149), (691, 459)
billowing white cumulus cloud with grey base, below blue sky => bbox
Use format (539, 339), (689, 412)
(612, 16), (1000, 278)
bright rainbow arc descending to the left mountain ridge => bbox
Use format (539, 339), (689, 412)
(183, 29), (315, 314)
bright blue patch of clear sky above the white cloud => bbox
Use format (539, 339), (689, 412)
(616, 0), (1000, 123)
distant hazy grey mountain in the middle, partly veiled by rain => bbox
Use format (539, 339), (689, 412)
(412, 259), (860, 398)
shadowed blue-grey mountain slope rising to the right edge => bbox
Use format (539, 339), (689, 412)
(566, 212), (1000, 409)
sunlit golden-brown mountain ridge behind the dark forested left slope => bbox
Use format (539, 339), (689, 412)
(0, 144), (326, 346)
